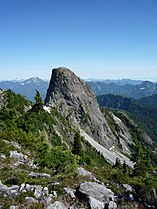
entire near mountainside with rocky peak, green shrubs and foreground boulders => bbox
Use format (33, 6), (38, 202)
(0, 68), (157, 209)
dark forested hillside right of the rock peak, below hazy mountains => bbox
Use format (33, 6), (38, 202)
(97, 94), (157, 143)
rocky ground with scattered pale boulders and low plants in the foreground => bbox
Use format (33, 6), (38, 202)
(0, 140), (147, 209)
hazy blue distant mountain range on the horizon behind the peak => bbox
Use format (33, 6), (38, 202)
(0, 77), (157, 101)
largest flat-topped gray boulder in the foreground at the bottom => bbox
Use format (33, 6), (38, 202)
(76, 182), (114, 203)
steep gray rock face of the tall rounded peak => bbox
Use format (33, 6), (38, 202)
(45, 67), (115, 148)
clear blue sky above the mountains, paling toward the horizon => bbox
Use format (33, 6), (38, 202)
(0, 0), (157, 81)
